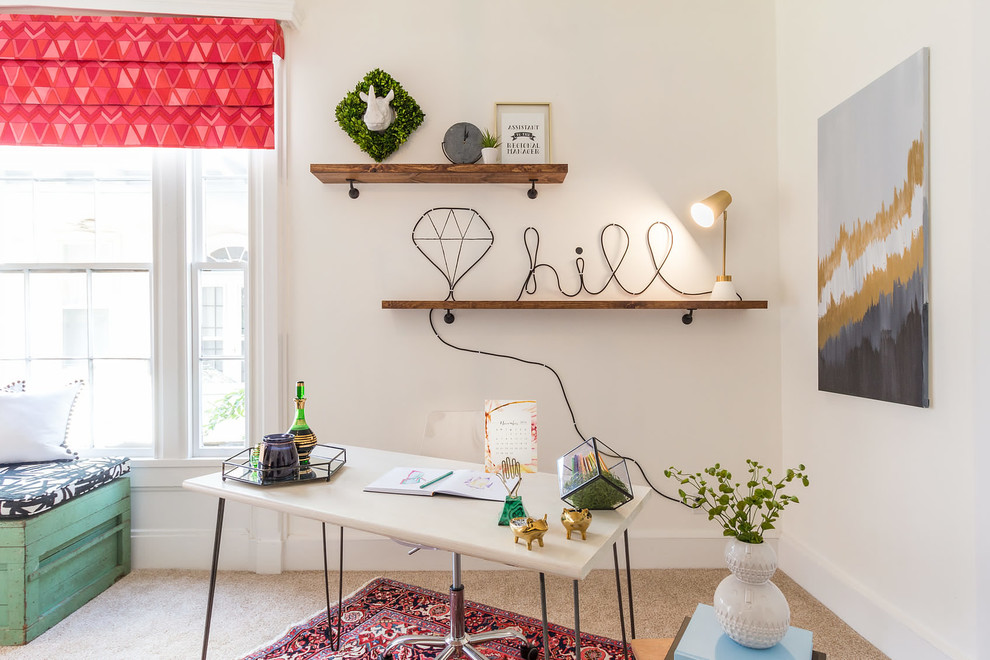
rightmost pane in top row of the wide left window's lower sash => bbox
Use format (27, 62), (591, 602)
(93, 272), (151, 358)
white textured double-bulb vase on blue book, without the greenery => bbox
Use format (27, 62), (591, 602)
(713, 539), (791, 649)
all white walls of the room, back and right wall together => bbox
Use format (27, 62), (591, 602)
(118, 0), (990, 658)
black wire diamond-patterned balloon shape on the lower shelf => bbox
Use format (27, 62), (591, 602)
(413, 207), (495, 300)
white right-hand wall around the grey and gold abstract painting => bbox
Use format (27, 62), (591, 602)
(776, 0), (987, 658)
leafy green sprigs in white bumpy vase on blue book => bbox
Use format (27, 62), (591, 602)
(663, 459), (809, 649)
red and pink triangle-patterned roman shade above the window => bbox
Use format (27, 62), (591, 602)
(0, 14), (284, 149)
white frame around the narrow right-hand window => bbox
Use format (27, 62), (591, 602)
(152, 149), (285, 460)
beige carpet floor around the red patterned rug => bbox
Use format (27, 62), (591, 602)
(0, 569), (886, 660)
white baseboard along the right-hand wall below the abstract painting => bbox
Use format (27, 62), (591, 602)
(778, 536), (975, 660)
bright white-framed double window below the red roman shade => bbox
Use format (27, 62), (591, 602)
(0, 147), (264, 458)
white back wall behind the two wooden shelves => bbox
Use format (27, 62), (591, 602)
(268, 0), (780, 565)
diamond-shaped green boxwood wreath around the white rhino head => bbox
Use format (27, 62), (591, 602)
(336, 69), (426, 163)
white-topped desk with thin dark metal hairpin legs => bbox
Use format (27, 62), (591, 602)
(183, 445), (652, 658)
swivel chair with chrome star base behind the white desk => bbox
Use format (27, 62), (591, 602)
(382, 410), (539, 660)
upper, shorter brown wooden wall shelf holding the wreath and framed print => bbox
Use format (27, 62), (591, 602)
(309, 163), (567, 199)
